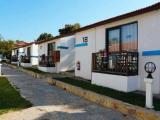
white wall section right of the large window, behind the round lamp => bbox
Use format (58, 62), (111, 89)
(138, 10), (160, 94)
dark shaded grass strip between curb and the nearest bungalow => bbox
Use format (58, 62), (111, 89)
(55, 77), (160, 111)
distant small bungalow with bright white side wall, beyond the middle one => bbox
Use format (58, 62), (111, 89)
(20, 42), (38, 67)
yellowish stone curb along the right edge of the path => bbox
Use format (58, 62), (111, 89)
(6, 64), (160, 120)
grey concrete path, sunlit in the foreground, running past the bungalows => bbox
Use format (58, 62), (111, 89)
(0, 65), (135, 120)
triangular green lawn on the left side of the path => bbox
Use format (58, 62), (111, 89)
(0, 77), (32, 115)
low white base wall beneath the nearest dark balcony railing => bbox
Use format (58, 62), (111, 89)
(92, 72), (138, 92)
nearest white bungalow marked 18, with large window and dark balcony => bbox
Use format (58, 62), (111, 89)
(75, 3), (160, 94)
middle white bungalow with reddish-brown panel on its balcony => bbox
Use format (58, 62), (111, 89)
(37, 34), (75, 73)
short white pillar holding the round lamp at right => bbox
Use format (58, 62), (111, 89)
(144, 78), (154, 109)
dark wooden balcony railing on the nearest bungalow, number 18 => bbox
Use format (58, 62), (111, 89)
(92, 51), (138, 76)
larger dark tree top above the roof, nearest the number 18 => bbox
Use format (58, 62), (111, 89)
(59, 23), (81, 35)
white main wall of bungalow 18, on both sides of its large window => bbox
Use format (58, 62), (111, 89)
(75, 10), (160, 93)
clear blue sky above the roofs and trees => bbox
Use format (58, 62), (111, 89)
(0, 0), (160, 41)
